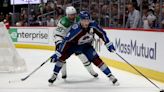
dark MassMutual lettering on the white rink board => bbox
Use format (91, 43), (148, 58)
(115, 38), (157, 60)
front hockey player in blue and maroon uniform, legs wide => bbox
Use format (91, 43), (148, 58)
(48, 11), (119, 85)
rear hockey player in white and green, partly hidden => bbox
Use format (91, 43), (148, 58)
(51, 6), (98, 79)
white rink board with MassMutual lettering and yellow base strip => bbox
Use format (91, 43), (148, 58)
(100, 29), (164, 82)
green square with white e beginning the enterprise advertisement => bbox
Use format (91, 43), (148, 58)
(9, 28), (18, 42)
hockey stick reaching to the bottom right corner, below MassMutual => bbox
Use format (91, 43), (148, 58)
(114, 51), (164, 92)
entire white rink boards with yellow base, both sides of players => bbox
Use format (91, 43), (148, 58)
(9, 27), (164, 82)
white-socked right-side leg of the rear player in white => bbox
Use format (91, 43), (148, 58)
(76, 53), (98, 77)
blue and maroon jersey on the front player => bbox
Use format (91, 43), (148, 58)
(57, 21), (109, 53)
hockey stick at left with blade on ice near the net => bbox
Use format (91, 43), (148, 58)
(9, 58), (51, 83)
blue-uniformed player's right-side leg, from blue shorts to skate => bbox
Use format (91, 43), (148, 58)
(84, 46), (119, 85)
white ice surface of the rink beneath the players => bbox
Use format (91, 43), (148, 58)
(0, 49), (164, 92)
